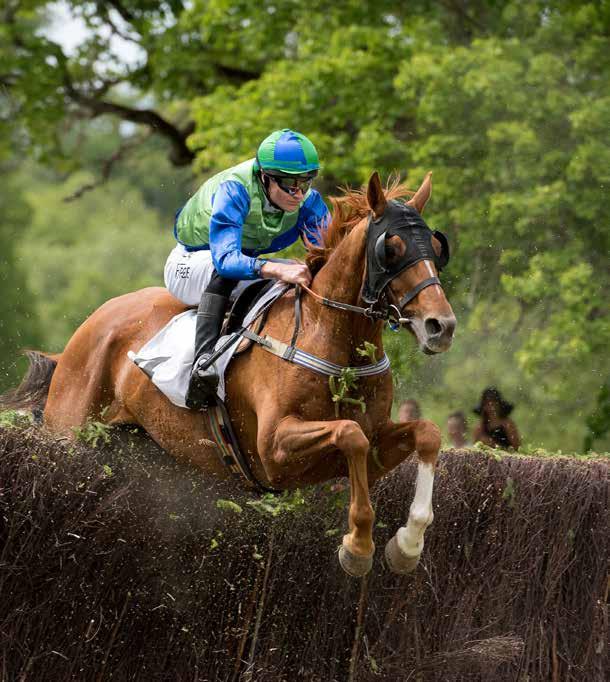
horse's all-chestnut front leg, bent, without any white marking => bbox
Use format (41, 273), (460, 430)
(259, 417), (375, 576)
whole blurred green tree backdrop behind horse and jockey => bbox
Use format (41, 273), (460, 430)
(0, 0), (610, 452)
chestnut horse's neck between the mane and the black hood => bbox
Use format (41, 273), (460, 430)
(312, 224), (383, 365)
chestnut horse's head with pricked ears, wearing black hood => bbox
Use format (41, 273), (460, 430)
(362, 172), (456, 354)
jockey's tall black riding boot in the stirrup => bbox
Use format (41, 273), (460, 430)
(186, 291), (229, 409)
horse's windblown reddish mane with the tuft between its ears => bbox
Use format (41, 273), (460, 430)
(305, 177), (415, 274)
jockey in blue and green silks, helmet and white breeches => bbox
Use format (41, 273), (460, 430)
(165, 128), (330, 409)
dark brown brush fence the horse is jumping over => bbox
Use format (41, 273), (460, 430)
(0, 428), (609, 682)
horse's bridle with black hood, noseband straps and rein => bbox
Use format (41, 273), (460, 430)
(300, 201), (450, 329)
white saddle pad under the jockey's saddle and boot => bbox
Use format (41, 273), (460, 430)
(127, 282), (289, 408)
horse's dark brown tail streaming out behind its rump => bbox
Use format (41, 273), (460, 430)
(0, 350), (61, 416)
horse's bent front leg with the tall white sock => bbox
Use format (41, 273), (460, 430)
(378, 419), (441, 573)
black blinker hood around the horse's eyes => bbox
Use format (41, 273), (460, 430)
(362, 200), (449, 304)
